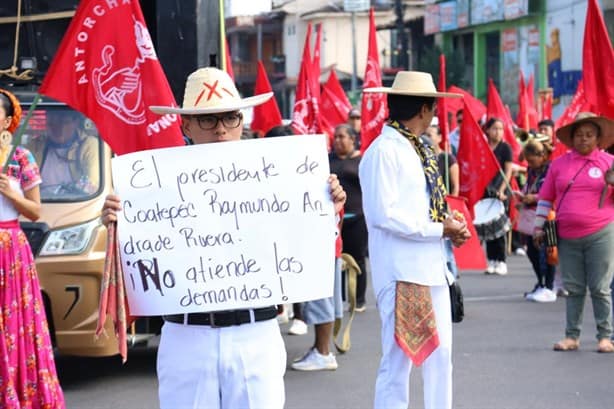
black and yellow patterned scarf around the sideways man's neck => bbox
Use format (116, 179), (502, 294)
(388, 120), (448, 222)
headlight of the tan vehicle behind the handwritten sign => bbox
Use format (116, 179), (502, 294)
(39, 219), (100, 256)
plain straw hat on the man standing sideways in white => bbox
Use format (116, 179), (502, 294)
(363, 71), (462, 98)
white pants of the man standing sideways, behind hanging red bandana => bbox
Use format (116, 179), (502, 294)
(375, 283), (452, 409)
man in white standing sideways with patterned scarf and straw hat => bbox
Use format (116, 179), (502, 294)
(359, 71), (470, 409)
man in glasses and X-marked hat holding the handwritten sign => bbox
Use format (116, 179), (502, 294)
(102, 67), (345, 409)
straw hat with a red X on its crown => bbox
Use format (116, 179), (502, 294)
(149, 67), (273, 115)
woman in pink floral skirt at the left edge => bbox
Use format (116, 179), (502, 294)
(0, 90), (65, 409)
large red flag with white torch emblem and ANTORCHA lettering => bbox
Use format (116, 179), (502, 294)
(40, 0), (184, 155)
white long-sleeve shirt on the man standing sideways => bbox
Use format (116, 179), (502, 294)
(359, 125), (454, 296)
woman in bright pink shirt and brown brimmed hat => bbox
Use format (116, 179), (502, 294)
(534, 114), (614, 352)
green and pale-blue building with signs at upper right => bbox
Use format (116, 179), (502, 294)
(424, 0), (614, 118)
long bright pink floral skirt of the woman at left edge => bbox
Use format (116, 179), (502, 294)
(0, 220), (65, 409)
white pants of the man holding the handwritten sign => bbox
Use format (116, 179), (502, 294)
(157, 319), (286, 409)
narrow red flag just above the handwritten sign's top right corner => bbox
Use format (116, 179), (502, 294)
(292, 23), (321, 134)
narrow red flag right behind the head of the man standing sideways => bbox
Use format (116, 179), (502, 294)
(360, 8), (388, 152)
